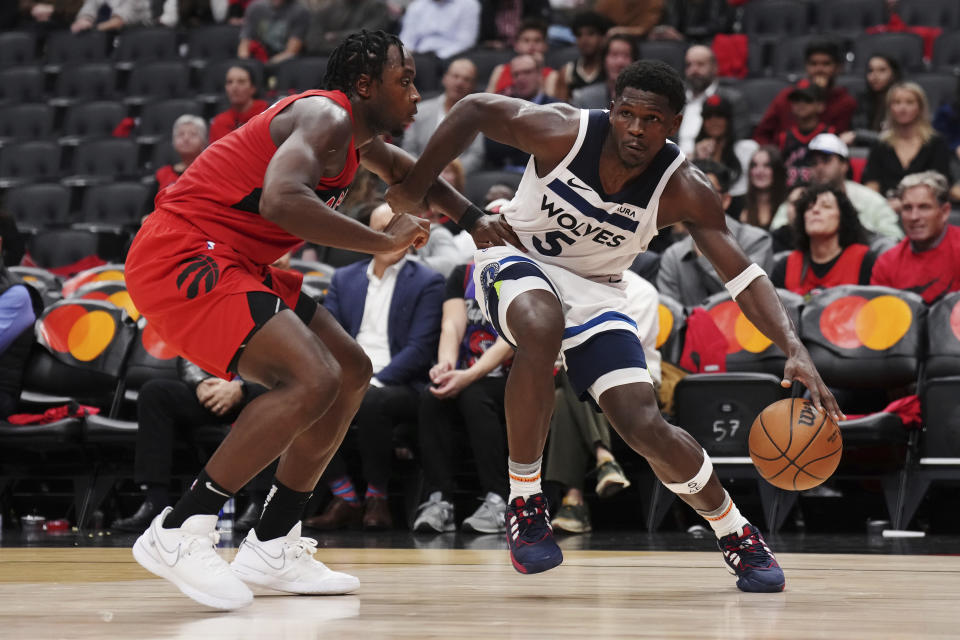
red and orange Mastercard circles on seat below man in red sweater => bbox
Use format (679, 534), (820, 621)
(819, 295), (916, 351)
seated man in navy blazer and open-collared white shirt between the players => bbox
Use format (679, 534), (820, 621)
(304, 202), (444, 529)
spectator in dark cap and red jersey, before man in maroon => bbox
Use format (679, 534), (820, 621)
(777, 78), (834, 187)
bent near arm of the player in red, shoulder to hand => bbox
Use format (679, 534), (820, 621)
(260, 99), (430, 253)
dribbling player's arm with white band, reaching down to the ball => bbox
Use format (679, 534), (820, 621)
(672, 166), (844, 420)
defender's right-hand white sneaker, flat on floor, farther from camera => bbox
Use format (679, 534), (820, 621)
(230, 522), (360, 595)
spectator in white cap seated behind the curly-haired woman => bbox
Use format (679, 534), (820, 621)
(770, 133), (903, 240)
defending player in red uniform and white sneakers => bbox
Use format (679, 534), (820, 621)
(126, 31), (518, 609)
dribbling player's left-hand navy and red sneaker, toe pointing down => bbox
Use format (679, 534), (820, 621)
(505, 493), (563, 573)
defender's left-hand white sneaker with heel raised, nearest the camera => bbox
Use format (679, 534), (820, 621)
(133, 507), (253, 609)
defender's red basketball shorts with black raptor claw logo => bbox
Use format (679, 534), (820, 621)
(125, 210), (317, 379)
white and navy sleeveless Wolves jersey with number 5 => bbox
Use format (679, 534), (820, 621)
(500, 109), (684, 282)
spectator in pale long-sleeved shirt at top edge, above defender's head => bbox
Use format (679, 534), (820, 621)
(400, 0), (480, 59)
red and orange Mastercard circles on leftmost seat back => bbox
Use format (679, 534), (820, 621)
(39, 303), (120, 362)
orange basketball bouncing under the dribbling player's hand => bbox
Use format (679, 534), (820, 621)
(749, 398), (843, 491)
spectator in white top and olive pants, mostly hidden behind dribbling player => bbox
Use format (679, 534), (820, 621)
(543, 271), (660, 533)
